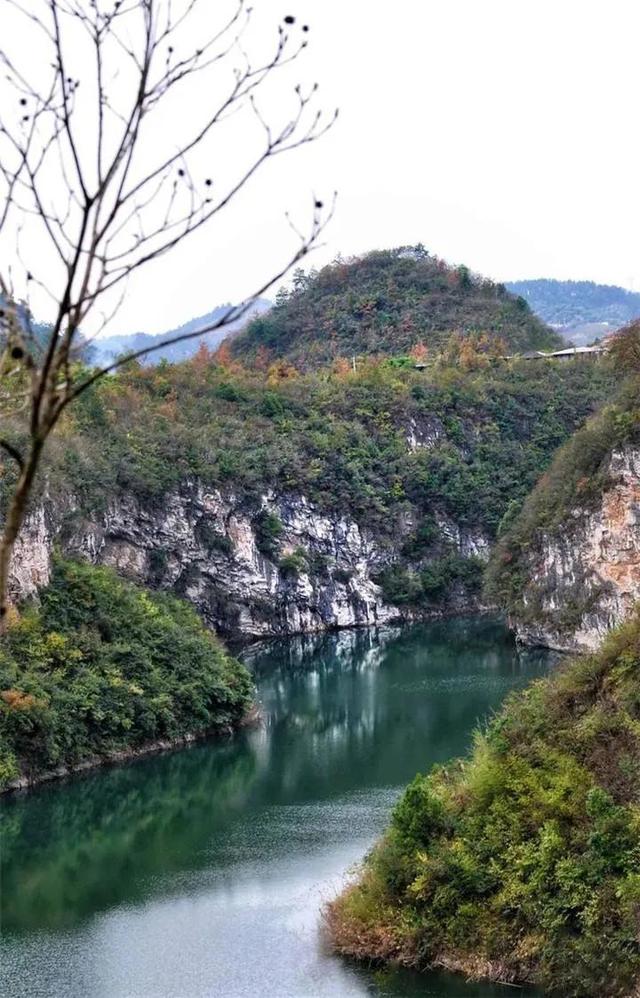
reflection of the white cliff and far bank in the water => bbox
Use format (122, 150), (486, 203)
(245, 618), (549, 802)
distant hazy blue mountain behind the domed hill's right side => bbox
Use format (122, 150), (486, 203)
(505, 279), (640, 346)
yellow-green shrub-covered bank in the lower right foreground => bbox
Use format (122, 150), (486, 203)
(327, 617), (640, 998)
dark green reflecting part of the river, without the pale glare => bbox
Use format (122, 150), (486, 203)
(2, 620), (548, 932)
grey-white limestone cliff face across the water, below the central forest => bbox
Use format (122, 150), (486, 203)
(11, 481), (488, 637)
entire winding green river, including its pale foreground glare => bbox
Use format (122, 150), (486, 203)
(0, 620), (549, 998)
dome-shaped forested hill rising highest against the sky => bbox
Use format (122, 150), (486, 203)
(232, 246), (563, 369)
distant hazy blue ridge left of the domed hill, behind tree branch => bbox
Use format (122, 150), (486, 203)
(91, 298), (271, 374)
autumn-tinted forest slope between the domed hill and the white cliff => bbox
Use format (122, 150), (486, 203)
(23, 349), (612, 605)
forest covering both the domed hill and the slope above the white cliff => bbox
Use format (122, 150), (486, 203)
(4, 247), (612, 620)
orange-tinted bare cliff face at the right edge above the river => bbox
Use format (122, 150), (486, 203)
(513, 447), (640, 651)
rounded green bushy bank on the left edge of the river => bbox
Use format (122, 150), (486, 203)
(0, 560), (253, 788)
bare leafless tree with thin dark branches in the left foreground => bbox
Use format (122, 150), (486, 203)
(0, 0), (335, 618)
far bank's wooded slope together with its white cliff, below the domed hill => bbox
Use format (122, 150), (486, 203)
(7, 349), (612, 636)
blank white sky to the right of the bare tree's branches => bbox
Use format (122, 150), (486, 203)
(1, 0), (640, 332)
